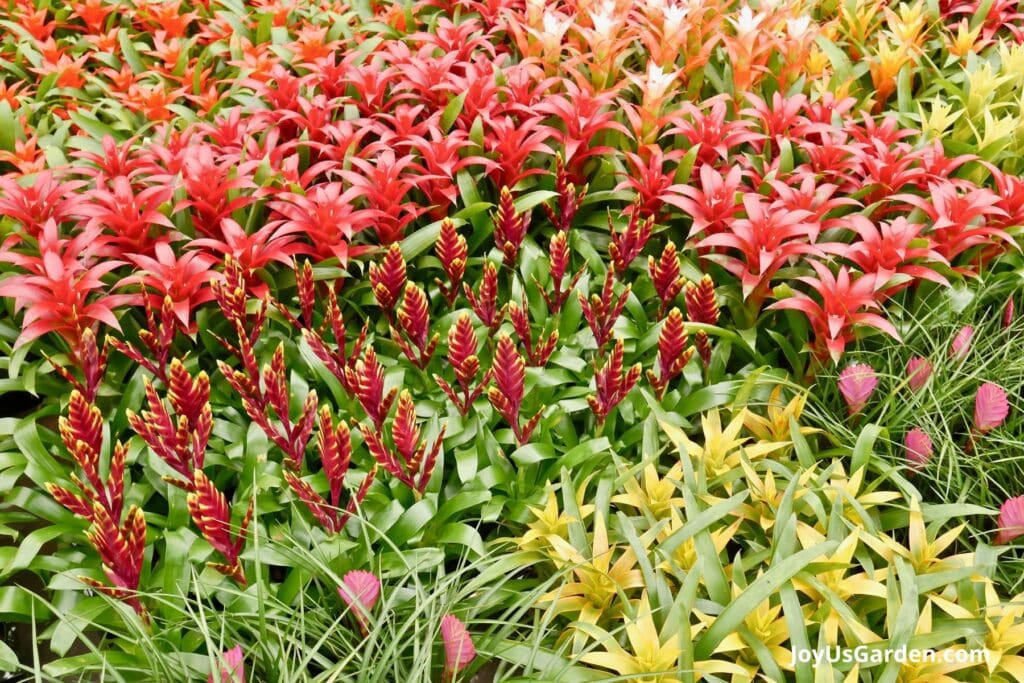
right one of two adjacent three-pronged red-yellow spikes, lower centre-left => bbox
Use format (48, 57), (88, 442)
(362, 390), (446, 496)
